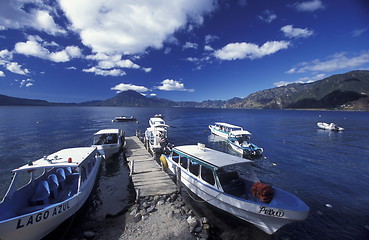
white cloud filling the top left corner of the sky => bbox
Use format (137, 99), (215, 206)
(0, 0), (66, 35)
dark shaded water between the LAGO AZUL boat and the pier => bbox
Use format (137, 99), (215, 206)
(43, 149), (134, 240)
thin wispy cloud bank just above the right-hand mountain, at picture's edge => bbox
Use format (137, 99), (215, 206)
(286, 51), (369, 73)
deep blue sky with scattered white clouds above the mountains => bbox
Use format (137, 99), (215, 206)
(0, 0), (369, 102)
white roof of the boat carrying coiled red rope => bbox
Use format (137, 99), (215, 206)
(173, 145), (252, 168)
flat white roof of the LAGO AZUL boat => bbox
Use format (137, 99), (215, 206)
(12, 147), (97, 172)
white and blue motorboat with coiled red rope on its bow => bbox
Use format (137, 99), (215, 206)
(160, 144), (309, 234)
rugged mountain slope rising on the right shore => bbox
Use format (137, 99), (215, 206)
(227, 71), (369, 110)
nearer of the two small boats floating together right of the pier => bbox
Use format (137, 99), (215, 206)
(227, 130), (263, 158)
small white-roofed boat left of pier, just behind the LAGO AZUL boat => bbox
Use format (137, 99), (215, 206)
(92, 129), (125, 158)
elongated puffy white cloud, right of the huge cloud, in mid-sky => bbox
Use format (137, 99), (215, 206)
(214, 41), (290, 60)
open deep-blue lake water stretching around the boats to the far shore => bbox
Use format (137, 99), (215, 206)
(0, 107), (369, 240)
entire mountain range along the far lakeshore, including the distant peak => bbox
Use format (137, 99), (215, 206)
(0, 71), (369, 110)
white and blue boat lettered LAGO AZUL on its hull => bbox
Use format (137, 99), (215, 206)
(0, 147), (102, 240)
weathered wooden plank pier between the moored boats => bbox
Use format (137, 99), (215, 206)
(126, 136), (176, 197)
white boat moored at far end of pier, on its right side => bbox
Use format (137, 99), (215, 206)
(145, 117), (169, 153)
